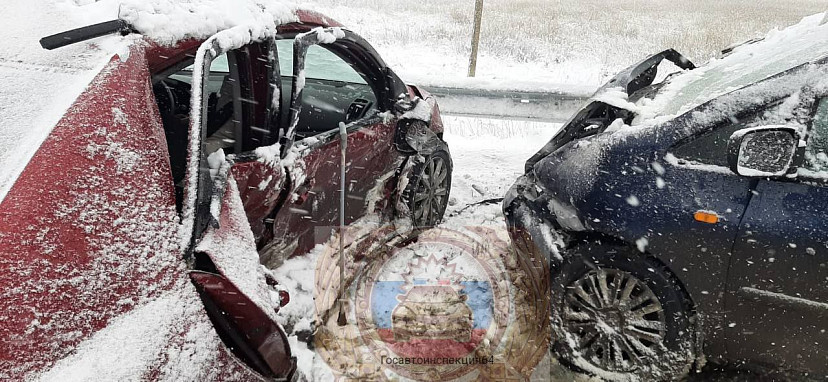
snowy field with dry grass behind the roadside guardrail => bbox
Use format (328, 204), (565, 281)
(296, 0), (828, 90)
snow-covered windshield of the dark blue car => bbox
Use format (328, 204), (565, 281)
(608, 13), (828, 124)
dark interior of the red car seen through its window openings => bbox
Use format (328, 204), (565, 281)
(152, 39), (377, 211)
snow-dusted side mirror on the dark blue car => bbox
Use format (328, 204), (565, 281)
(727, 125), (799, 177)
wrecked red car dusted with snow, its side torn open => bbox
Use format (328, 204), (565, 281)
(0, 6), (452, 380)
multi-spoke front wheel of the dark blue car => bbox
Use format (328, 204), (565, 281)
(552, 244), (695, 381)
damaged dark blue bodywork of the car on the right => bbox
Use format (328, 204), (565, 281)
(503, 42), (828, 375)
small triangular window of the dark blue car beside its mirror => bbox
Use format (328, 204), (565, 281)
(672, 104), (789, 167)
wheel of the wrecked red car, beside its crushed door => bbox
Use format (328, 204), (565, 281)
(404, 150), (452, 228)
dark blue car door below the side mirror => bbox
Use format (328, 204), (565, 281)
(725, 98), (828, 373)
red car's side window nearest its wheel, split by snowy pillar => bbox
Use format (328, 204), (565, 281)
(276, 39), (377, 139)
